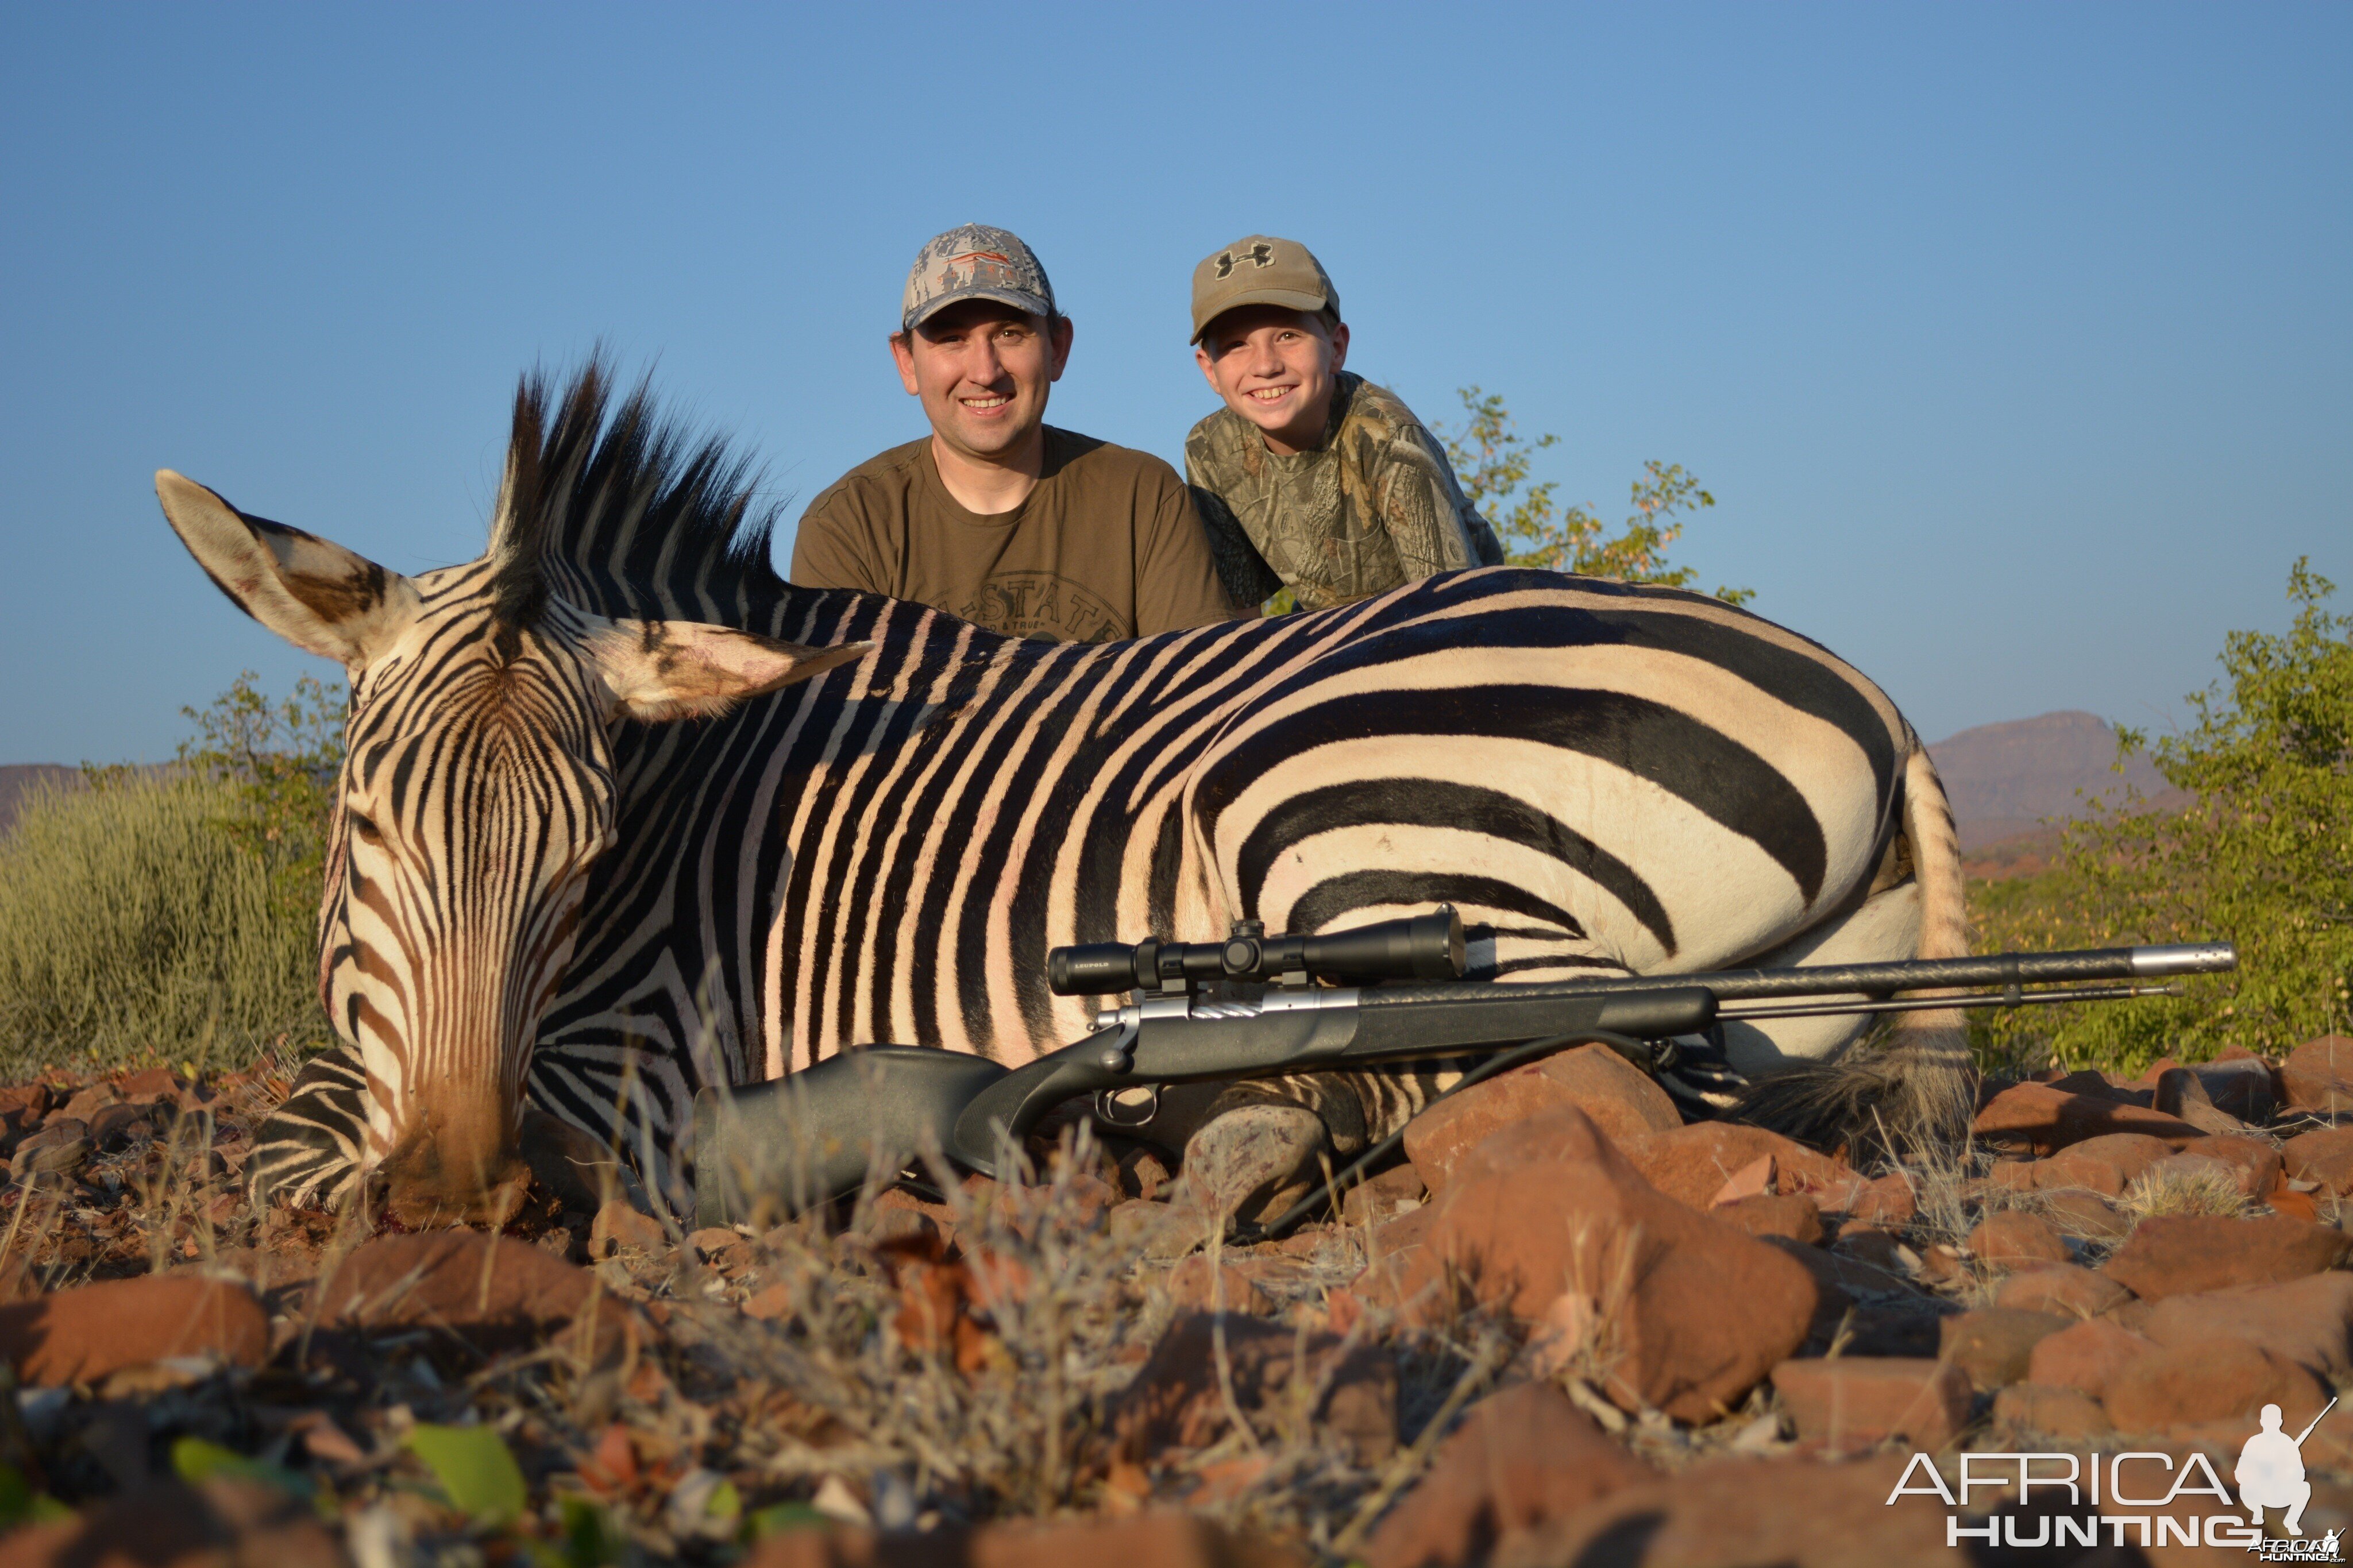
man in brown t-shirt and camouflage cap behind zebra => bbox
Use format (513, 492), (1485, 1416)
(793, 223), (1235, 642)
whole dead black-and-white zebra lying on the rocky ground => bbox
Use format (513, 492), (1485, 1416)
(155, 360), (1969, 1222)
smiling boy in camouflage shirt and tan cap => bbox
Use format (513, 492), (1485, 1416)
(1183, 235), (1503, 609)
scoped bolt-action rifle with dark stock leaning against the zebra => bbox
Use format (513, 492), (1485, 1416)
(694, 907), (2238, 1234)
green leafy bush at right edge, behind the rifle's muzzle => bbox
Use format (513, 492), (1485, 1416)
(1974, 559), (2353, 1069)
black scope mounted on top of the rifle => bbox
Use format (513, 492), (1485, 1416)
(1045, 905), (1464, 997)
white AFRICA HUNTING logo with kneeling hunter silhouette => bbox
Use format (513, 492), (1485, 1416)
(1887, 1399), (2346, 1563)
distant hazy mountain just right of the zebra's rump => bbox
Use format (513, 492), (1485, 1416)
(1927, 712), (2188, 860)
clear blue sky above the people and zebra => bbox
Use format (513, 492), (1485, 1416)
(0, 0), (2353, 762)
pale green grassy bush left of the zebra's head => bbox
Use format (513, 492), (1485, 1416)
(0, 673), (341, 1077)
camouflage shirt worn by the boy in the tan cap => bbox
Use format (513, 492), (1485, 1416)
(1183, 372), (1503, 609)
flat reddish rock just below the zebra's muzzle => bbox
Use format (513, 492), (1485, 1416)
(318, 1230), (619, 1351)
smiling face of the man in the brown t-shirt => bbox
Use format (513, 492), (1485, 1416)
(889, 299), (1071, 461)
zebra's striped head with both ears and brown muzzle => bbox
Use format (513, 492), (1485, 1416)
(155, 383), (866, 1225)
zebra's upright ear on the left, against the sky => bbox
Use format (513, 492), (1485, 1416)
(155, 468), (419, 670)
